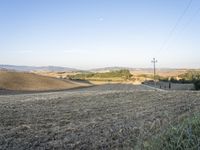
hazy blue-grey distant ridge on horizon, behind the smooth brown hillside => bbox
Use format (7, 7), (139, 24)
(0, 65), (78, 72)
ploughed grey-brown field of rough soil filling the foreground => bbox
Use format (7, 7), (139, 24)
(0, 84), (200, 149)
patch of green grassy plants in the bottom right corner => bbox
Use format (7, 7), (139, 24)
(145, 115), (200, 150)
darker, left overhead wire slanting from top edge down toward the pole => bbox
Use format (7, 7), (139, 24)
(160, 0), (193, 51)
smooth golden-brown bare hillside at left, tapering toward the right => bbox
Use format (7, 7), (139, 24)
(0, 71), (89, 91)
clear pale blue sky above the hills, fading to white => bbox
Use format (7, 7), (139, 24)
(0, 0), (200, 69)
